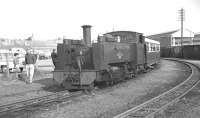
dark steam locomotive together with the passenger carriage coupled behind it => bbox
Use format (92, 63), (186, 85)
(53, 25), (160, 89)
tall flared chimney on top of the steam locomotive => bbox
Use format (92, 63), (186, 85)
(82, 25), (92, 46)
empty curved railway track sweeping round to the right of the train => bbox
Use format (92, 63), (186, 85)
(114, 59), (200, 118)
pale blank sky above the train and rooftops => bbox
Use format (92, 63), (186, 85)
(0, 0), (200, 40)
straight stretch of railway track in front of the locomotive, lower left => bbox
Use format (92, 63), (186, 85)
(0, 91), (82, 116)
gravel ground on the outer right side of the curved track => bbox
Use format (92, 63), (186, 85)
(153, 60), (200, 118)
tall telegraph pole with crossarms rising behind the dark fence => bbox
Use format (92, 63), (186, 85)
(179, 8), (185, 57)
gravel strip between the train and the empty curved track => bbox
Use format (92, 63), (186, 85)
(26, 60), (190, 118)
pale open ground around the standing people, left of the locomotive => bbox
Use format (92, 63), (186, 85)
(0, 60), (63, 104)
